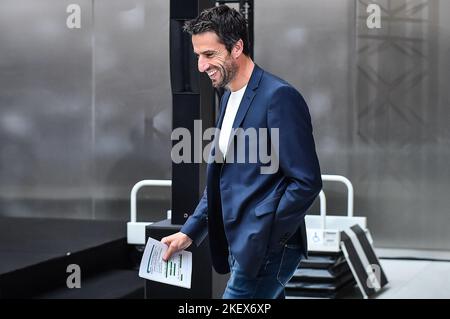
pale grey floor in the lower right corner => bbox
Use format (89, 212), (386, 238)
(349, 249), (450, 299)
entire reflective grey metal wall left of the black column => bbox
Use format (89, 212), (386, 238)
(0, 0), (171, 219)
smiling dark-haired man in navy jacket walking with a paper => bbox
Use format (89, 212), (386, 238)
(161, 5), (322, 298)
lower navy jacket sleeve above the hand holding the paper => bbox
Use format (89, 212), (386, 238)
(180, 188), (208, 246)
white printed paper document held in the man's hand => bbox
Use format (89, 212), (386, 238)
(139, 238), (192, 289)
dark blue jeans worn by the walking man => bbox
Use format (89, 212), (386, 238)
(222, 245), (304, 299)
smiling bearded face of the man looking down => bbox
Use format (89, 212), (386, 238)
(192, 32), (238, 88)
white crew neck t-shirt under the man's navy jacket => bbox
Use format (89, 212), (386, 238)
(219, 85), (247, 158)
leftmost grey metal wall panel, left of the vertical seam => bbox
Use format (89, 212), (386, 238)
(0, 0), (91, 217)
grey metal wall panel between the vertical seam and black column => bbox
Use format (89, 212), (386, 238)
(93, 0), (172, 217)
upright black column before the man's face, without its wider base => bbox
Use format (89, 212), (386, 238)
(170, 0), (215, 224)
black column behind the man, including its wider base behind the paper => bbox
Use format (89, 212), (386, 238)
(145, 0), (218, 299)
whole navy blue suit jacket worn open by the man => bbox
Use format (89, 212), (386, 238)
(181, 65), (322, 277)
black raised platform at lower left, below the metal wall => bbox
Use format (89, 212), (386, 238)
(0, 218), (138, 298)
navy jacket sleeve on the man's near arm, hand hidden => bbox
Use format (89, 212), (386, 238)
(267, 85), (322, 243)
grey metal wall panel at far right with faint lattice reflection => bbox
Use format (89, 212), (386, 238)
(354, 0), (450, 249)
